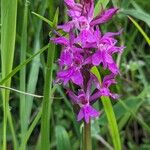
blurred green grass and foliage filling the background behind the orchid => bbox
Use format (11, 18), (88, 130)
(0, 0), (150, 150)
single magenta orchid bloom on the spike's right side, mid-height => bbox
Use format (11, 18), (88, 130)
(92, 28), (124, 74)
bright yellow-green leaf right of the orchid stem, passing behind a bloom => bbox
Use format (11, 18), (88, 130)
(91, 67), (121, 150)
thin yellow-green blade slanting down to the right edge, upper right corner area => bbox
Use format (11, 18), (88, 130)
(128, 16), (150, 45)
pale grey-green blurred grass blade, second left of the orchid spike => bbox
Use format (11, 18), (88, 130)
(26, 0), (47, 133)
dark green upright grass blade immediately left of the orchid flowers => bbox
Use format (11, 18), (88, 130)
(41, 43), (55, 150)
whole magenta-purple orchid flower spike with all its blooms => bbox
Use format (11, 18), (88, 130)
(51, 0), (124, 123)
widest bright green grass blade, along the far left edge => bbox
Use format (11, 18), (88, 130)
(1, 0), (17, 150)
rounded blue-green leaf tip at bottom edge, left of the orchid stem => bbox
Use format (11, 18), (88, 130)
(55, 125), (71, 150)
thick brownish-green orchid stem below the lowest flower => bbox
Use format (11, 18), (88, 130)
(83, 122), (92, 150)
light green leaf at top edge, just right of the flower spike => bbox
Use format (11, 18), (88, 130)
(94, 0), (109, 16)
